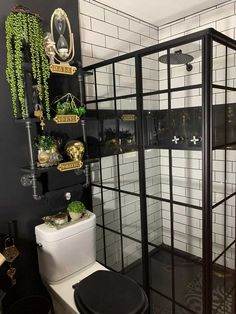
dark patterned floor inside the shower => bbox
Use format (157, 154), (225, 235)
(126, 248), (236, 314)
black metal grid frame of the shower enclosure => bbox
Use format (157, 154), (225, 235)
(84, 28), (236, 314)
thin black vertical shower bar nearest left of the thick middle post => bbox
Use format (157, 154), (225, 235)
(112, 63), (124, 273)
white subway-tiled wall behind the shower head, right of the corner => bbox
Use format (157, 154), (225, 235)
(159, 1), (236, 268)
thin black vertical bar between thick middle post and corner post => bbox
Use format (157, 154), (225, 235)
(167, 49), (175, 314)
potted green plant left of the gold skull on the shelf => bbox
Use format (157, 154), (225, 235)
(34, 135), (62, 167)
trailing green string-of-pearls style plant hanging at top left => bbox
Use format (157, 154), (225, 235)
(5, 6), (50, 119)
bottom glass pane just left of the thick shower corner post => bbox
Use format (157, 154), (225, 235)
(173, 204), (203, 314)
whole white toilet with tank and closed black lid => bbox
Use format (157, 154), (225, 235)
(35, 211), (148, 314)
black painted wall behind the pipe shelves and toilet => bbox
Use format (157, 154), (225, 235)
(0, 0), (84, 303)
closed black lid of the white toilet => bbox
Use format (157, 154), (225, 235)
(74, 270), (148, 314)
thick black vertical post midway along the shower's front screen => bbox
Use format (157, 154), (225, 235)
(135, 55), (150, 298)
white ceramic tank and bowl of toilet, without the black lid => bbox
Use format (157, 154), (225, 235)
(35, 211), (106, 314)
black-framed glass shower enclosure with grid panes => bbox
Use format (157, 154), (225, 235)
(84, 29), (236, 314)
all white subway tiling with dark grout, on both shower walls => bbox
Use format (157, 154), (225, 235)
(80, 0), (236, 270)
